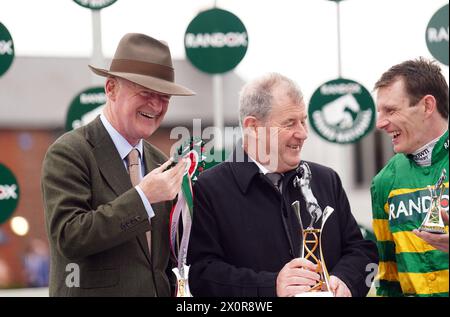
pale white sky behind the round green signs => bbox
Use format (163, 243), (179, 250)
(0, 0), (448, 100)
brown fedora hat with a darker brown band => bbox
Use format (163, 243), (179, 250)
(89, 33), (195, 96)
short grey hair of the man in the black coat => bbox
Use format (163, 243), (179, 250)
(239, 73), (303, 127)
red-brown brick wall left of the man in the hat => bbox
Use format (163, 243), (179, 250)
(0, 129), (55, 285)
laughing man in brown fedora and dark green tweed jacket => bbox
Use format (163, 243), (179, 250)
(42, 33), (194, 297)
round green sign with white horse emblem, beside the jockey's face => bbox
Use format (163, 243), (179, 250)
(308, 78), (375, 144)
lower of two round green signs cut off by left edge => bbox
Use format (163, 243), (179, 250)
(0, 163), (20, 224)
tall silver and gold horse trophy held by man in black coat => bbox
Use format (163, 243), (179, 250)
(292, 162), (334, 297)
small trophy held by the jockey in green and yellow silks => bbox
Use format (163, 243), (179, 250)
(419, 168), (447, 233)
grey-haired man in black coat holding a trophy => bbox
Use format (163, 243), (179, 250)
(188, 73), (378, 297)
